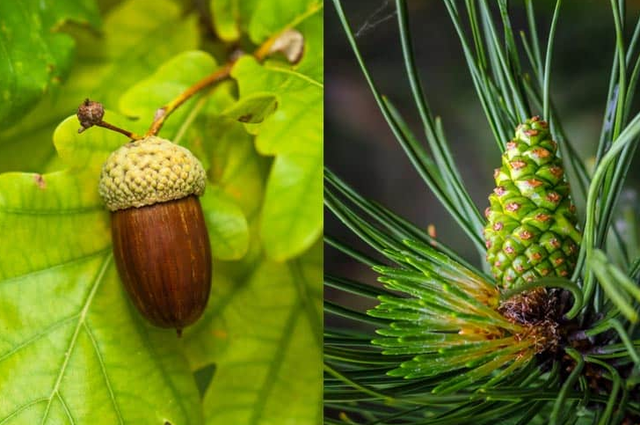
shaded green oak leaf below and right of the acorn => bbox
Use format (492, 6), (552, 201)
(185, 244), (322, 425)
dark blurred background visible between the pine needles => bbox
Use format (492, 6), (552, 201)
(325, 0), (640, 325)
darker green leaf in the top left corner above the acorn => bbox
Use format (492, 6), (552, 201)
(0, 0), (100, 128)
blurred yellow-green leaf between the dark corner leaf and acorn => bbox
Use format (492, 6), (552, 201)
(0, 0), (199, 172)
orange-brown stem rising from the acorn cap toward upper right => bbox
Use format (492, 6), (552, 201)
(144, 30), (299, 137)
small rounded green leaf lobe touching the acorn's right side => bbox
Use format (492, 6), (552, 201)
(200, 187), (249, 260)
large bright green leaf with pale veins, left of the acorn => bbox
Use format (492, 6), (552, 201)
(0, 172), (202, 425)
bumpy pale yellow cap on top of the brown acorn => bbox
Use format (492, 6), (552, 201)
(99, 136), (207, 211)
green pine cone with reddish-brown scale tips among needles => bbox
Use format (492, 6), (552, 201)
(484, 117), (582, 288)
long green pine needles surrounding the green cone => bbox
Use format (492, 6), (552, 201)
(325, 0), (640, 425)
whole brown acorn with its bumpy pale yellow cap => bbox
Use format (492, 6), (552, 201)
(100, 136), (211, 336)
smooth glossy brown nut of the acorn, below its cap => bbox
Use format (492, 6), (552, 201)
(111, 195), (211, 335)
